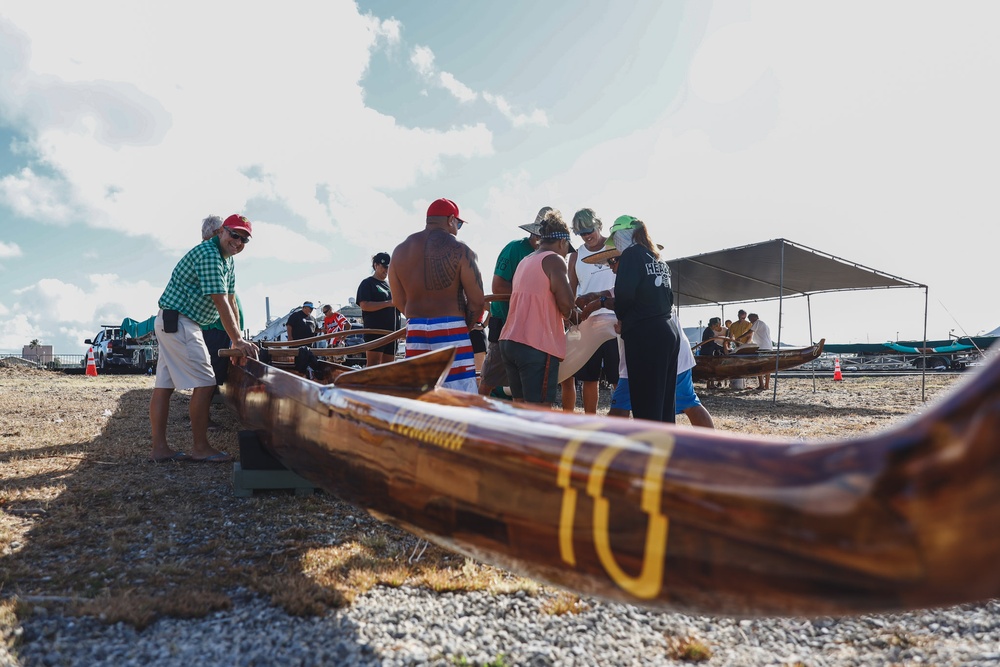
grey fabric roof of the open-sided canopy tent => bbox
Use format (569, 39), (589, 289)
(668, 239), (926, 306)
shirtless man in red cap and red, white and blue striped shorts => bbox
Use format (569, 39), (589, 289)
(389, 199), (486, 393)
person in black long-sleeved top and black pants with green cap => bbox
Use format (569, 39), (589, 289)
(608, 215), (681, 422)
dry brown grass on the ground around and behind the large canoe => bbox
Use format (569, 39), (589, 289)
(0, 366), (968, 639)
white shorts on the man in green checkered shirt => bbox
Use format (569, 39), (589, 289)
(153, 310), (215, 389)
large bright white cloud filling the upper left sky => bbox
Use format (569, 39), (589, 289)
(0, 3), (492, 260)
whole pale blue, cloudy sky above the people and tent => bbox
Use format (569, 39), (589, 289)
(0, 0), (1000, 354)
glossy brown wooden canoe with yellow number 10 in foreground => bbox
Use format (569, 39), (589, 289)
(224, 336), (1000, 616)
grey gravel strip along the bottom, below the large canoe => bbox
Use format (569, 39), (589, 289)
(11, 587), (1000, 667)
